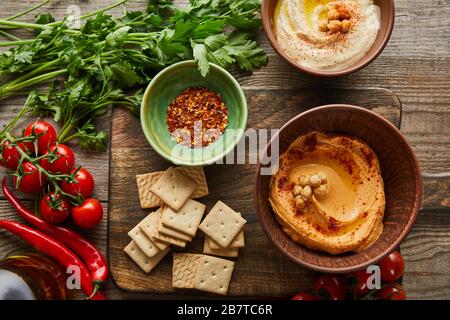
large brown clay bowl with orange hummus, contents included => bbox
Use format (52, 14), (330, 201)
(254, 105), (422, 273)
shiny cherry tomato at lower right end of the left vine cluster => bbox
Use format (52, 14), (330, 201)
(72, 198), (103, 229)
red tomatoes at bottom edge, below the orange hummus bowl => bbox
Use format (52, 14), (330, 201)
(292, 251), (406, 300)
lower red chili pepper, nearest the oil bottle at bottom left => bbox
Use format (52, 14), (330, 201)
(0, 220), (105, 300)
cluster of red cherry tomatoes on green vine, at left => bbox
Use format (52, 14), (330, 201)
(0, 120), (103, 229)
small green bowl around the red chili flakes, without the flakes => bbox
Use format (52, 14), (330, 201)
(141, 60), (247, 166)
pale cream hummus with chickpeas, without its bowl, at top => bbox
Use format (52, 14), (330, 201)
(274, 0), (380, 71)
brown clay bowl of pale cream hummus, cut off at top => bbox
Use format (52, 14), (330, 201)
(261, 0), (395, 77)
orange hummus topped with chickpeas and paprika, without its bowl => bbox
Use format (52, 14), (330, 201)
(269, 132), (386, 254)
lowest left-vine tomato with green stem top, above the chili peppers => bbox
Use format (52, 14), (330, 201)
(39, 192), (71, 223)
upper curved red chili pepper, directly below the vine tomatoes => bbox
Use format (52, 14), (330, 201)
(2, 178), (108, 289)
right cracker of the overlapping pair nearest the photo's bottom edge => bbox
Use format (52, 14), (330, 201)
(194, 256), (234, 295)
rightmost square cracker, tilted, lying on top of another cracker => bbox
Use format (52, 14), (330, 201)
(200, 201), (247, 248)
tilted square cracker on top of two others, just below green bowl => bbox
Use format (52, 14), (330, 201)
(150, 167), (197, 211)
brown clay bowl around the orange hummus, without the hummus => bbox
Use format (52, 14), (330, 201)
(254, 105), (422, 273)
